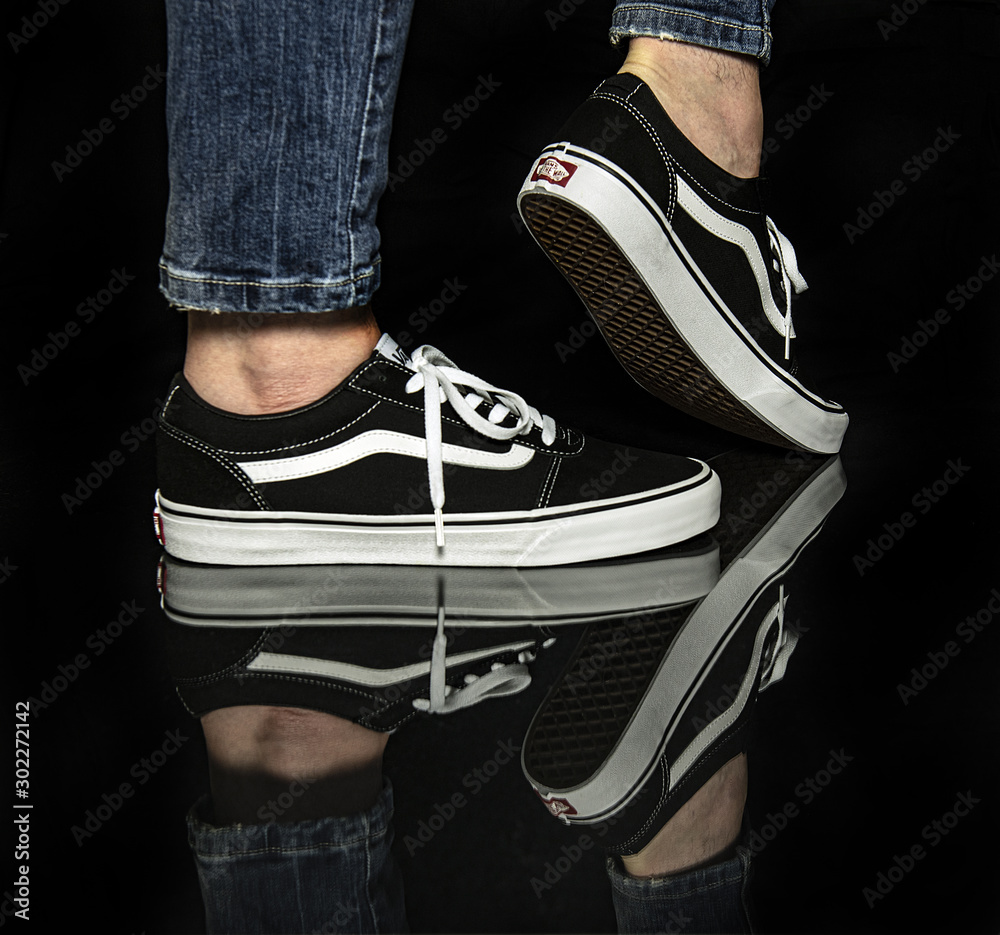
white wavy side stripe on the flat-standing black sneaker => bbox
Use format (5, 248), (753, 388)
(240, 429), (535, 484)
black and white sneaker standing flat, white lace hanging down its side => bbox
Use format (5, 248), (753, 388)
(155, 335), (720, 566)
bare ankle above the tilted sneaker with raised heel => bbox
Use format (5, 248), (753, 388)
(620, 37), (764, 178)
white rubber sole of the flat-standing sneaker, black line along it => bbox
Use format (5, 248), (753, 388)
(155, 464), (722, 567)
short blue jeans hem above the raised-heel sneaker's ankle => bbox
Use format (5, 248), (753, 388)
(608, 0), (774, 65)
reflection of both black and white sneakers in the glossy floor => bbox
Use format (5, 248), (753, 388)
(159, 449), (846, 935)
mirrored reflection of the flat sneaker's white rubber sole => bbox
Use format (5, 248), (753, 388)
(157, 533), (719, 628)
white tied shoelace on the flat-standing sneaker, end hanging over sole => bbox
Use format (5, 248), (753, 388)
(406, 344), (556, 549)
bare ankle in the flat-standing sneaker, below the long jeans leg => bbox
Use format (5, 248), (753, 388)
(184, 306), (379, 415)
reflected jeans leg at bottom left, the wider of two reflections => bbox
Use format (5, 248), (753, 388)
(187, 780), (408, 933)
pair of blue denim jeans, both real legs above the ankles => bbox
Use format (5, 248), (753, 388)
(160, 0), (774, 312)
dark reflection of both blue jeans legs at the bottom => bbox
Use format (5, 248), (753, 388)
(188, 780), (750, 935)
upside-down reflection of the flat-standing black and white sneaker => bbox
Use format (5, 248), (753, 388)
(157, 534), (719, 730)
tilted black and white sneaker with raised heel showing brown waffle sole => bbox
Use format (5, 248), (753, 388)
(518, 74), (848, 454)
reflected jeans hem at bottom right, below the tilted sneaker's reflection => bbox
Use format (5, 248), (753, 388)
(607, 848), (752, 935)
